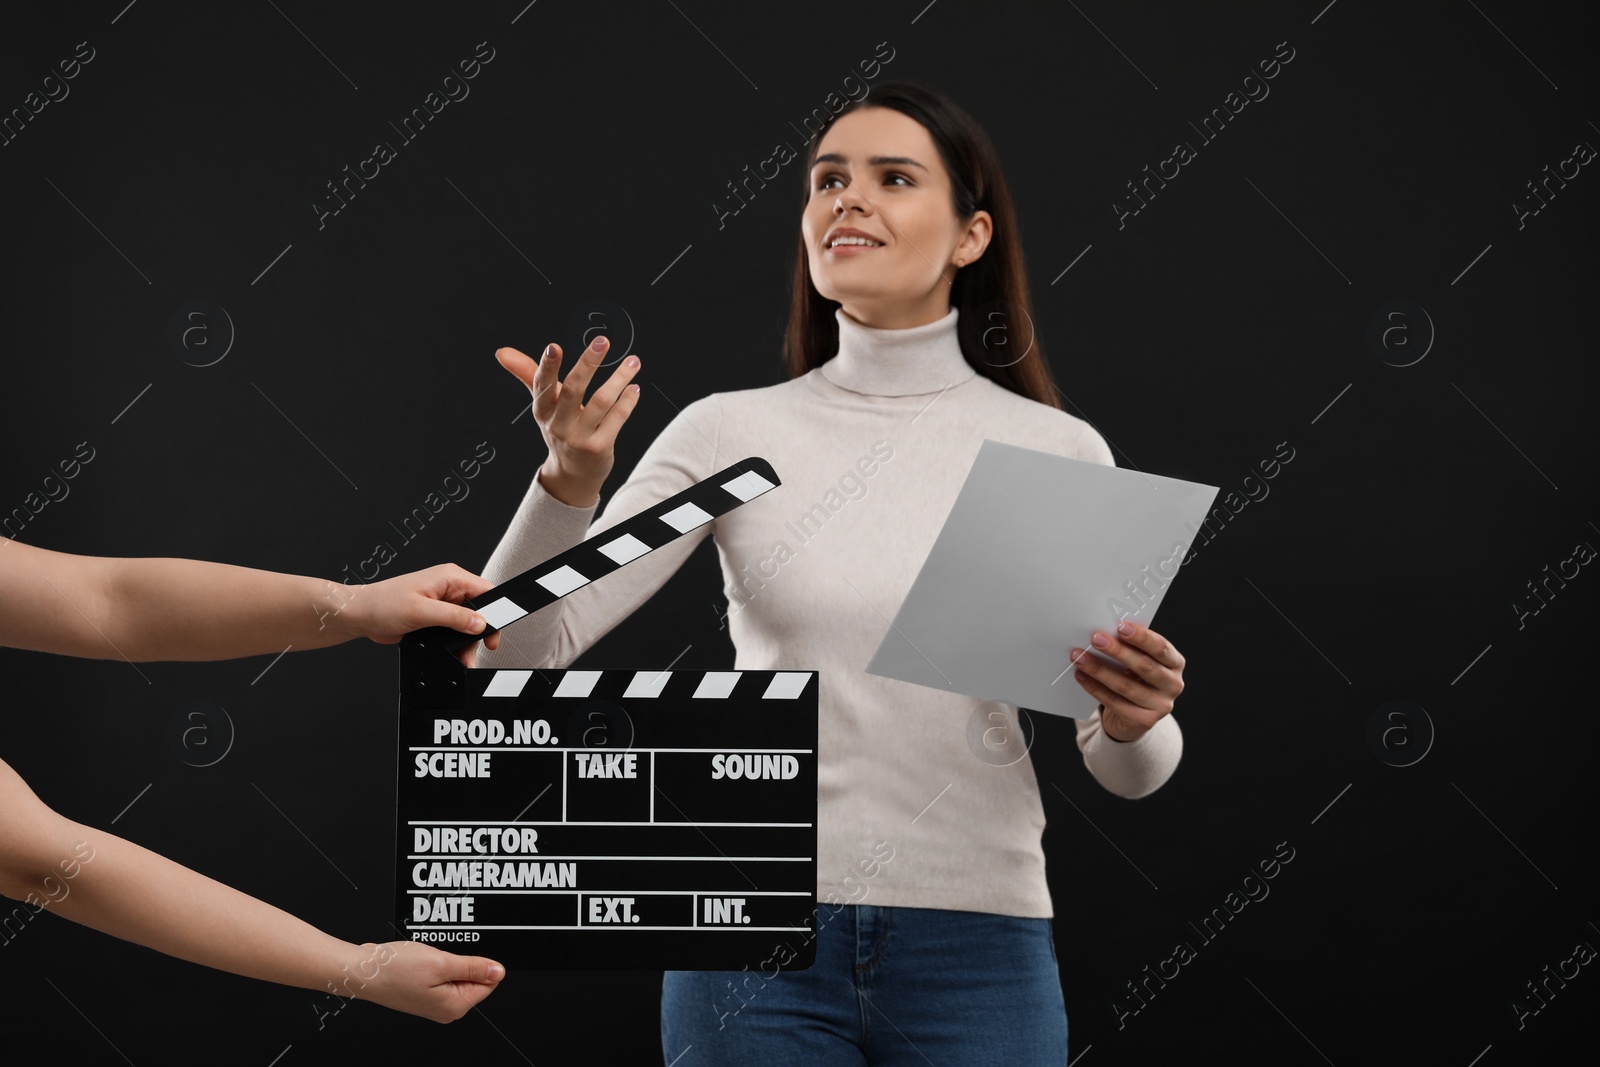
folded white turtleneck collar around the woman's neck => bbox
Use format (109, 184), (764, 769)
(818, 307), (978, 397)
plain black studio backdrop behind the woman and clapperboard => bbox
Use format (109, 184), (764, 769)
(0, 0), (1600, 1067)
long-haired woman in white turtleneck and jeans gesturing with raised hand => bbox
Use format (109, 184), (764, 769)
(483, 83), (1184, 1067)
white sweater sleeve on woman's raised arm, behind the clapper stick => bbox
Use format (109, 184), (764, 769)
(477, 394), (726, 667)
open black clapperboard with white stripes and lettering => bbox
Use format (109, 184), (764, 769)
(395, 458), (818, 969)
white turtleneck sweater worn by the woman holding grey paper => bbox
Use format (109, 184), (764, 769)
(478, 307), (1182, 917)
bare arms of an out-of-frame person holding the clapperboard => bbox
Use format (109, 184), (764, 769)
(0, 541), (506, 1022)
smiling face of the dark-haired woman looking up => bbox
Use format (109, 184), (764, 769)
(800, 107), (990, 330)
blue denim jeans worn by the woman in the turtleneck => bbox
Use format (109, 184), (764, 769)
(661, 904), (1067, 1067)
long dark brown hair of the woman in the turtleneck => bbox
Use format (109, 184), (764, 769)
(782, 82), (1061, 410)
